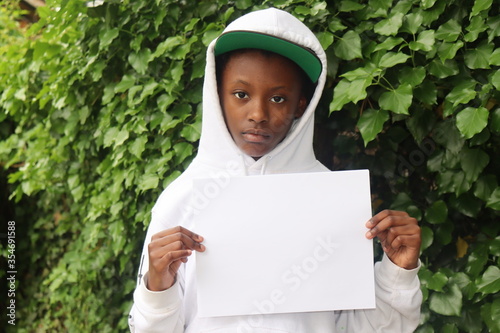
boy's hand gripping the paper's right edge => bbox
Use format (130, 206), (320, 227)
(366, 210), (421, 269)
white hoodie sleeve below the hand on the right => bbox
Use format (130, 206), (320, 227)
(336, 254), (422, 333)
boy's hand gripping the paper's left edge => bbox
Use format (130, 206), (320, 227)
(147, 226), (205, 291)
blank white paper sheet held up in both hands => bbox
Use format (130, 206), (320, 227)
(194, 170), (375, 317)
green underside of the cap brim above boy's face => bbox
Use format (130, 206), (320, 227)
(215, 31), (321, 83)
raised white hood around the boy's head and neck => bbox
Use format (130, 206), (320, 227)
(193, 8), (326, 175)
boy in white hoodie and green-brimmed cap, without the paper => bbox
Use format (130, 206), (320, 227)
(129, 9), (422, 333)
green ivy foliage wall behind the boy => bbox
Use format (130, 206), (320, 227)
(0, 0), (500, 333)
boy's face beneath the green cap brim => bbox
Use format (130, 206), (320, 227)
(219, 50), (307, 159)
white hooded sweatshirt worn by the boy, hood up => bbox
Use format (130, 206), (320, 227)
(129, 9), (422, 333)
